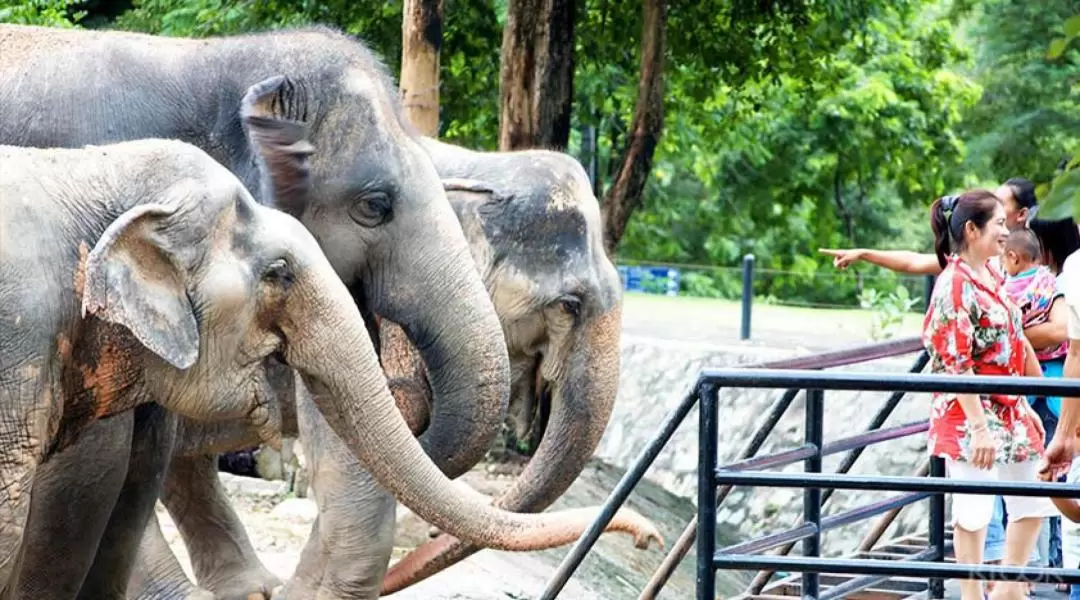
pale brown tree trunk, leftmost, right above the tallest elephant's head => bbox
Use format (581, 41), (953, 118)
(401, 0), (443, 137)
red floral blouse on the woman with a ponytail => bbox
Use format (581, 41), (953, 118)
(922, 256), (1043, 463)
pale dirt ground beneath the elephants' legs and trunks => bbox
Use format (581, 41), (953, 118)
(158, 461), (747, 600)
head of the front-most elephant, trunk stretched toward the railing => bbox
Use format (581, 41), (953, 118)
(82, 142), (660, 565)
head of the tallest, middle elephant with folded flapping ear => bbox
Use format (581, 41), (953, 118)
(234, 63), (509, 478)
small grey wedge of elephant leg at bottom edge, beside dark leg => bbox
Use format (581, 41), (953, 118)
(127, 516), (214, 600)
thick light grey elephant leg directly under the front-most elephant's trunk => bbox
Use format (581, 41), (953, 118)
(275, 379), (397, 600)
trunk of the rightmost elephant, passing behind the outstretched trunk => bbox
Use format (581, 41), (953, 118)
(382, 304), (621, 595)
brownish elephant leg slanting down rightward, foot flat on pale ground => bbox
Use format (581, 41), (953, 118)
(162, 454), (281, 600)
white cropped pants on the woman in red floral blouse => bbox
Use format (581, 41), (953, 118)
(945, 460), (1061, 531)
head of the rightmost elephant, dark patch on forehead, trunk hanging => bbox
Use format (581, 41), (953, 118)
(383, 139), (622, 594)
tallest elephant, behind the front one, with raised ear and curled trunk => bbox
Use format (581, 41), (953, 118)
(0, 25), (509, 598)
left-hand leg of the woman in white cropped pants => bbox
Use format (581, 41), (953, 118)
(946, 461), (997, 600)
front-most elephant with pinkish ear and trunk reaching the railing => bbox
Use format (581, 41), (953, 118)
(0, 139), (657, 598)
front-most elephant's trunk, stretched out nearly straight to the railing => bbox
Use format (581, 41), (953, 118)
(283, 276), (663, 551)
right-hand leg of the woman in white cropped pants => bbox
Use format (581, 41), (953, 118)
(993, 459), (1056, 600)
